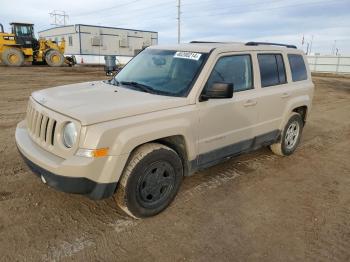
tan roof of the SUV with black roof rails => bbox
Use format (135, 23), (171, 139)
(150, 41), (303, 53)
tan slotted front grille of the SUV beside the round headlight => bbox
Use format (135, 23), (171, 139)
(27, 103), (57, 146)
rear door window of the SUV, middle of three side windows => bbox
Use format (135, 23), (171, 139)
(258, 54), (287, 87)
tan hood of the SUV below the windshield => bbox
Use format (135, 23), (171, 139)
(32, 81), (188, 125)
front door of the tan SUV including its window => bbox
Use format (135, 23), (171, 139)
(198, 54), (258, 166)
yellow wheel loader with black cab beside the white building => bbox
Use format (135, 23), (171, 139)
(0, 23), (76, 66)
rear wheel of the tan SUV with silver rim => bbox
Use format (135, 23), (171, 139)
(270, 113), (304, 156)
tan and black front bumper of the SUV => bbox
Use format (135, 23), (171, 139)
(15, 121), (125, 200)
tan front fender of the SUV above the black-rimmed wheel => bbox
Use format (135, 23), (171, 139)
(80, 106), (198, 160)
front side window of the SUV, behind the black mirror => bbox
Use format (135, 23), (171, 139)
(205, 55), (253, 92)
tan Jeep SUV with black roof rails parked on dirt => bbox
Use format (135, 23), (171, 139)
(16, 42), (314, 218)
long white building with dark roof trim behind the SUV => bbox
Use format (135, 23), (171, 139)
(39, 24), (158, 64)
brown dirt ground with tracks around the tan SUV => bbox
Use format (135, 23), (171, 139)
(0, 67), (350, 261)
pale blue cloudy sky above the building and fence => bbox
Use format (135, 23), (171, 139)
(0, 0), (350, 55)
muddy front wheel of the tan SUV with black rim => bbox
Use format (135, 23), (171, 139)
(115, 143), (183, 218)
